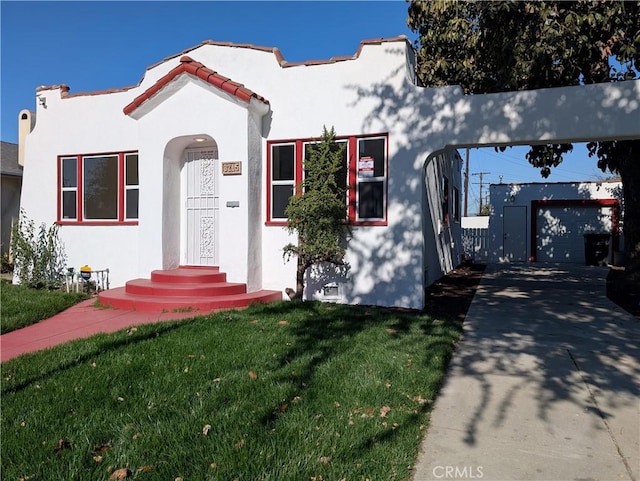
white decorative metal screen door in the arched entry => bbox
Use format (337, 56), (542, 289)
(183, 149), (219, 266)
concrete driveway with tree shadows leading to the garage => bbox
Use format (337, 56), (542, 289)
(414, 264), (640, 481)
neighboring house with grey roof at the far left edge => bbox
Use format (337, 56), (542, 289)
(0, 142), (22, 254)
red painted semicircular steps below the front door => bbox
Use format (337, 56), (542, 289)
(98, 266), (282, 312)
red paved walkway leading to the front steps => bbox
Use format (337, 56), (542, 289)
(0, 299), (220, 362)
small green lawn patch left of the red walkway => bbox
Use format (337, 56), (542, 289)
(0, 282), (88, 334)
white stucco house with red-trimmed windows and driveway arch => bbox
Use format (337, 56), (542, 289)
(20, 36), (640, 308)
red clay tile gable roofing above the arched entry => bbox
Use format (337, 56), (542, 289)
(123, 55), (269, 115)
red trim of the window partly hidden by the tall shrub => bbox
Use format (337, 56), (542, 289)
(265, 132), (389, 227)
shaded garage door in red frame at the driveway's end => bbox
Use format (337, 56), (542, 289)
(536, 206), (613, 264)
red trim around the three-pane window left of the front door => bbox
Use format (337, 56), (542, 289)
(55, 150), (138, 226)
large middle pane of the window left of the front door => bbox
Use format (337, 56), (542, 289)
(83, 155), (118, 220)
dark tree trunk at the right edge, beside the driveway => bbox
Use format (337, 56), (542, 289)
(618, 148), (640, 282)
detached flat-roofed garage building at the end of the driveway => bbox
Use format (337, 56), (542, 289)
(489, 181), (623, 264)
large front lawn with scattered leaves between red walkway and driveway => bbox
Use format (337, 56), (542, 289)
(1, 302), (461, 481)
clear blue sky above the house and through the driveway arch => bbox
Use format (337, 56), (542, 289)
(0, 0), (604, 211)
